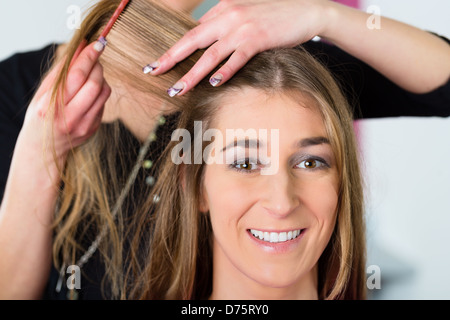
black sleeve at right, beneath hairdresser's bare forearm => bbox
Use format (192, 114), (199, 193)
(304, 33), (450, 119)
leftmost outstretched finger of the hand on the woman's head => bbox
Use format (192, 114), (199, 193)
(144, 18), (223, 75)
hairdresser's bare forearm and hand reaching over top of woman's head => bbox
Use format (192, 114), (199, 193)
(150, 0), (450, 96)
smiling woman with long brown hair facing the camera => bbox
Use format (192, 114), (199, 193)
(131, 47), (365, 299)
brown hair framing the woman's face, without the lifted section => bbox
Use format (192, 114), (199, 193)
(134, 47), (365, 299)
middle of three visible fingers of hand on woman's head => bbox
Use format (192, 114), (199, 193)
(169, 39), (234, 96)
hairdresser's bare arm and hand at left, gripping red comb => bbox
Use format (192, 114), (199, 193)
(0, 40), (110, 300)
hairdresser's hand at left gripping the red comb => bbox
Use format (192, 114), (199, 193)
(21, 42), (111, 162)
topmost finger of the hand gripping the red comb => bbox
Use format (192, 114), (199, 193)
(65, 41), (104, 104)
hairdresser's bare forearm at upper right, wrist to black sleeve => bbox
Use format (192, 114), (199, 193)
(321, 2), (450, 93)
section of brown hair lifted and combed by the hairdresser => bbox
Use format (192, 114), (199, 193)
(47, 0), (198, 298)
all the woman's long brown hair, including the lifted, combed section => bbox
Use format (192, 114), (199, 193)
(48, 0), (364, 299)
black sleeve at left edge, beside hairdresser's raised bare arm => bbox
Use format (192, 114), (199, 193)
(0, 45), (56, 201)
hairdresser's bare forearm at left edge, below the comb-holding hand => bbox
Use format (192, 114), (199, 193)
(0, 137), (59, 299)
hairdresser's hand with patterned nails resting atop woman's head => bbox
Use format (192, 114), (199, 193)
(145, 0), (329, 95)
